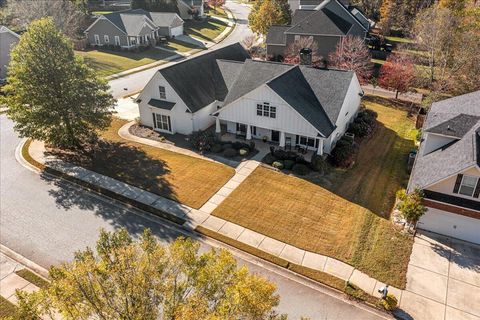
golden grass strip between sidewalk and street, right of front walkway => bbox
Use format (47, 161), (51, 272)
(195, 226), (379, 308)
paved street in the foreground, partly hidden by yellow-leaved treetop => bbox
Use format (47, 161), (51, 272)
(0, 115), (388, 319)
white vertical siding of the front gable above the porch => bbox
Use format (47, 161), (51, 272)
(219, 85), (317, 137)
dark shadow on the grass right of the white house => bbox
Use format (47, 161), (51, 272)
(307, 123), (415, 219)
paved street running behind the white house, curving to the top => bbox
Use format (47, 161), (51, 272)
(109, 1), (251, 98)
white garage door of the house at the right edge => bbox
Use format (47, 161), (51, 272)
(418, 208), (480, 243)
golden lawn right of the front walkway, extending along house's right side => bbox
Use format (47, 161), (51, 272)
(213, 98), (415, 288)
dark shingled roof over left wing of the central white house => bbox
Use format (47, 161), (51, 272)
(158, 43), (250, 112)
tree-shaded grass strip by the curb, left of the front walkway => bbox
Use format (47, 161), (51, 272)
(22, 139), (185, 225)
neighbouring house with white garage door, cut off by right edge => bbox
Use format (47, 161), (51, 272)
(408, 91), (480, 243)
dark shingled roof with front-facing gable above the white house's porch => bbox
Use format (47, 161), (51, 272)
(219, 60), (354, 137)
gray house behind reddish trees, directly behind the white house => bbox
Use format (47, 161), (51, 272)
(266, 0), (369, 59)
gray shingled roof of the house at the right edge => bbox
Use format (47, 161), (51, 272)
(408, 91), (480, 190)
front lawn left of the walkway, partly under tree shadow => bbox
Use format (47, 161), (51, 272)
(49, 119), (235, 208)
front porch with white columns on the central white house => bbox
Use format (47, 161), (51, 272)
(215, 118), (323, 161)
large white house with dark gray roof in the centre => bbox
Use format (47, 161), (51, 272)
(137, 43), (363, 154)
